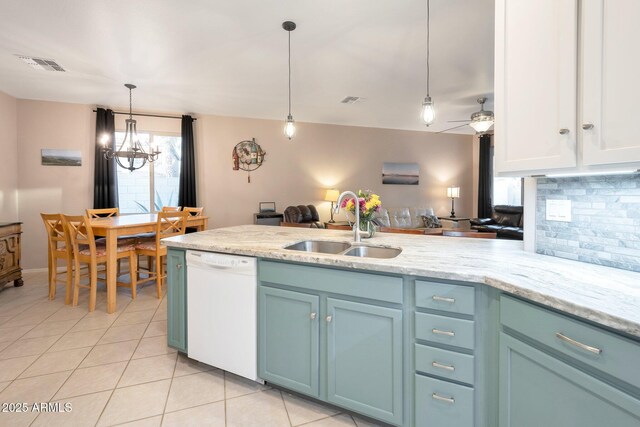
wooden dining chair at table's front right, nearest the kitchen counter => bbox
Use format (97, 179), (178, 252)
(136, 212), (188, 299)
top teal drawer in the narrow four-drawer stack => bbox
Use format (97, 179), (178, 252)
(416, 280), (475, 315)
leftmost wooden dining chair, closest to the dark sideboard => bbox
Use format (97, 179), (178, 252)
(40, 213), (73, 304)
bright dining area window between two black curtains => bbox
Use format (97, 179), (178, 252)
(116, 132), (182, 213)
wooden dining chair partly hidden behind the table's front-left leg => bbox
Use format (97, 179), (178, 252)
(62, 215), (138, 311)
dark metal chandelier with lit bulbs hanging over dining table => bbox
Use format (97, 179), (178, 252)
(102, 83), (161, 172)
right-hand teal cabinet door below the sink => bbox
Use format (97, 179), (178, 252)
(324, 298), (402, 424)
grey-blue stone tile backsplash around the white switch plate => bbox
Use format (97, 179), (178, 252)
(536, 173), (640, 272)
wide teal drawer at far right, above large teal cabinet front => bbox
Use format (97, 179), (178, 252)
(500, 295), (640, 387)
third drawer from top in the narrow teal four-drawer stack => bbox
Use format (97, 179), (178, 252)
(415, 344), (474, 385)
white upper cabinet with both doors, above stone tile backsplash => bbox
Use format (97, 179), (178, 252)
(495, 0), (640, 175)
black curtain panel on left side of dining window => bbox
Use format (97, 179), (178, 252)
(93, 108), (118, 209)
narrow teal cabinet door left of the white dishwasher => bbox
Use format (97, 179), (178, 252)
(167, 249), (187, 353)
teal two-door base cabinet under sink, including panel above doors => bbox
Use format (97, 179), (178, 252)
(258, 260), (407, 425)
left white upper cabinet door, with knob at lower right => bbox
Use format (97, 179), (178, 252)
(495, 0), (576, 172)
